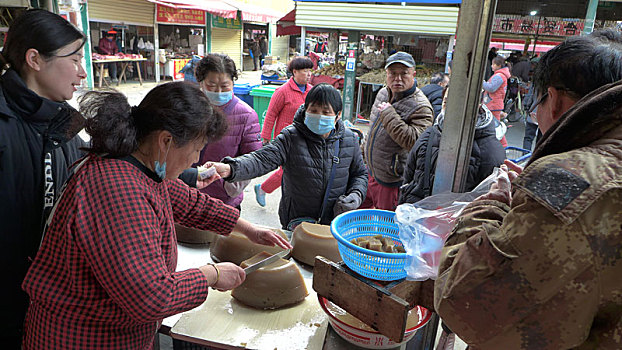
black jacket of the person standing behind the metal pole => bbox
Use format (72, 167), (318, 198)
(399, 110), (505, 204)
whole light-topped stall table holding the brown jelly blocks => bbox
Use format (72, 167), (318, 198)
(160, 243), (414, 350)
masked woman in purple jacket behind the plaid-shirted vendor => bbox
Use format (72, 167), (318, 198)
(191, 54), (261, 209)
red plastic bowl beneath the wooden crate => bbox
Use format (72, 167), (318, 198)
(318, 295), (432, 349)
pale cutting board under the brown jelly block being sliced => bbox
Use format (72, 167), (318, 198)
(171, 264), (328, 350)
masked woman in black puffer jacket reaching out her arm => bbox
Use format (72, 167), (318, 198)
(216, 84), (367, 229)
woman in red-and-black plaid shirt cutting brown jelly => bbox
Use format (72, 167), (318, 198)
(22, 82), (290, 349)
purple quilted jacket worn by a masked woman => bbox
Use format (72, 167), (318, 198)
(194, 96), (261, 207)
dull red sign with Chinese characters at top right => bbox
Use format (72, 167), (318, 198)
(492, 15), (585, 37)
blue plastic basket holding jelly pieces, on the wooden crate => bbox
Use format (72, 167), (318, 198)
(330, 209), (406, 281)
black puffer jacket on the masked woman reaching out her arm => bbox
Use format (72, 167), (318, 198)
(223, 105), (367, 227)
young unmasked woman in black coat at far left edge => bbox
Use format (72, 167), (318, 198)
(0, 10), (86, 349)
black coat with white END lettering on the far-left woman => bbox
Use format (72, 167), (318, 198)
(0, 70), (85, 342)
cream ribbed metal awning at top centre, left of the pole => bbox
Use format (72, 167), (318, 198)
(296, 2), (458, 35)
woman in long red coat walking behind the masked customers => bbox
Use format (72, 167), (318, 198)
(255, 57), (313, 207)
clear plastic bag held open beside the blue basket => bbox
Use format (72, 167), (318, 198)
(395, 168), (507, 281)
